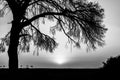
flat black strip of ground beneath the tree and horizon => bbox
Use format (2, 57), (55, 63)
(0, 68), (119, 80)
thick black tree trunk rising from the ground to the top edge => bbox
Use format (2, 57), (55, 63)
(6, 0), (27, 69)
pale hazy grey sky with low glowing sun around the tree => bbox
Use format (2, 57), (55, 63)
(0, 0), (120, 68)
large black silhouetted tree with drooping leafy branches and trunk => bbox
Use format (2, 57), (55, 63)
(0, 0), (107, 69)
